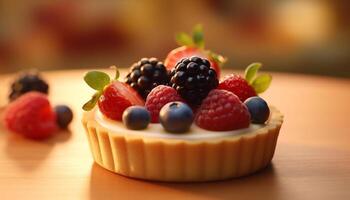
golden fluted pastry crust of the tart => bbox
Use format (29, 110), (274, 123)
(82, 108), (283, 182)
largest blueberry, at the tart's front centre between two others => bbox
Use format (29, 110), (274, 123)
(159, 101), (193, 133)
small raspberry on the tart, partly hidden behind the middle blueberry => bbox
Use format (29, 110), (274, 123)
(145, 85), (184, 123)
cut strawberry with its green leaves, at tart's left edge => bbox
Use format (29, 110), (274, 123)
(83, 67), (144, 121)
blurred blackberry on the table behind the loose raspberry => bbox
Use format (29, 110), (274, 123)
(9, 72), (49, 101)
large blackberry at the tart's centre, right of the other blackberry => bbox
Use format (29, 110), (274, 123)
(170, 56), (219, 106)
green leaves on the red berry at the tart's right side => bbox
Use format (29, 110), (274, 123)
(244, 63), (272, 94)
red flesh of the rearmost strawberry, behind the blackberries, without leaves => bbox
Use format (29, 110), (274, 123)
(164, 46), (220, 77)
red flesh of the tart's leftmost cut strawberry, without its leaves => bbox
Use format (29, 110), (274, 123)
(98, 81), (144, 121)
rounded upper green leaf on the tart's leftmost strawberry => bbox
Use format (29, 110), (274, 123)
(84, 71), (111, 91)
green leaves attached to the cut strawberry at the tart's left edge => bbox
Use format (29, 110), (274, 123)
(83, 66), (119, 111)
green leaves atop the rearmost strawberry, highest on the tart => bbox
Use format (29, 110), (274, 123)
(175, 24), (227, 66)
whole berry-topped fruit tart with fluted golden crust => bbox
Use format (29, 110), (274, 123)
(82, 25), (283, 182)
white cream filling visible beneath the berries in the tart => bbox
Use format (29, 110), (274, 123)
(95, 109), (265, 140)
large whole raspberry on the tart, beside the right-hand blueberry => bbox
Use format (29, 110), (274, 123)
(195, 89), (250, 131)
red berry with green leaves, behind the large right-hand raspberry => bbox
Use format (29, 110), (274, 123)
(218, 63), (271, 102)
